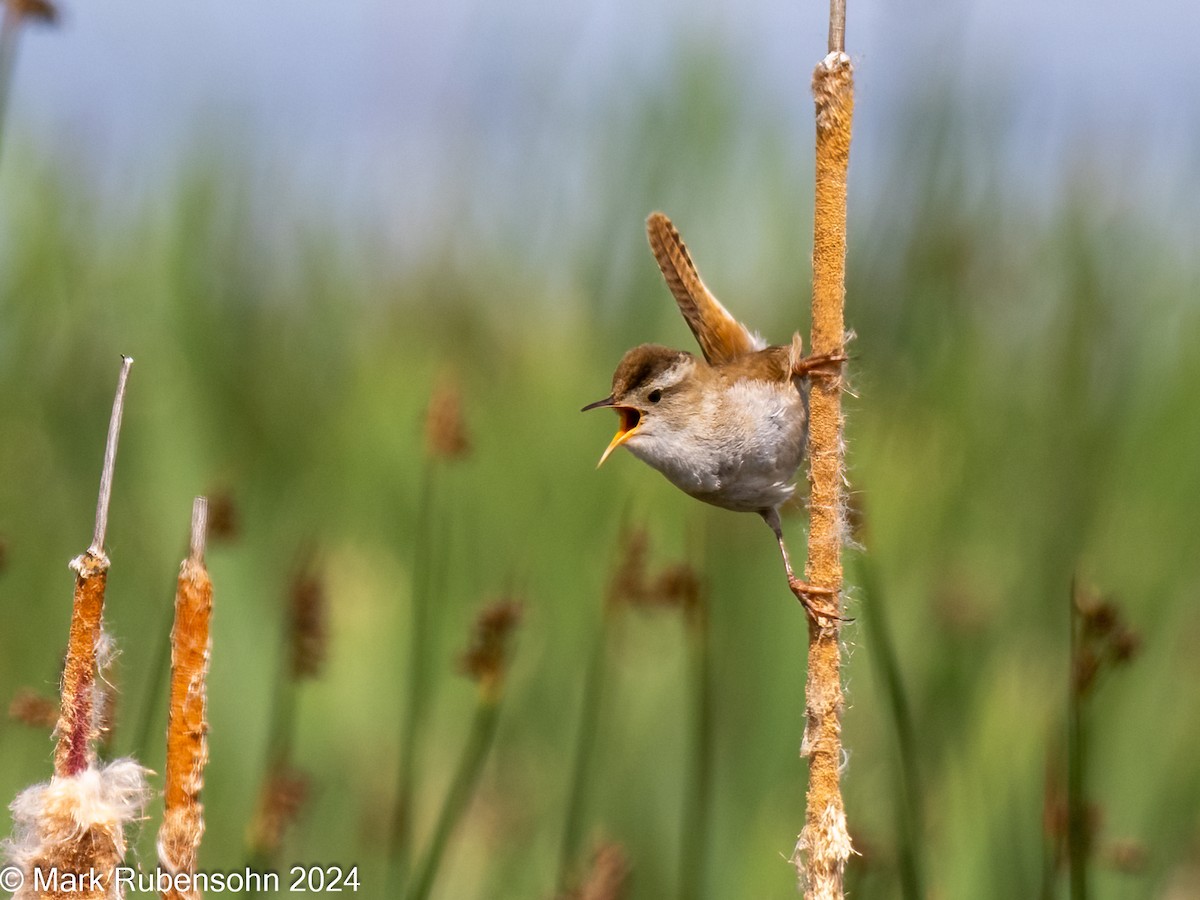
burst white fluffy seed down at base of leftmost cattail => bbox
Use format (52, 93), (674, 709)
(5, 760), (149, 900)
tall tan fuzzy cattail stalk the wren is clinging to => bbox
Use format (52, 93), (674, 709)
(793, 22), (854, 900)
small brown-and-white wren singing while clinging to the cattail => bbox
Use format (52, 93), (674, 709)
(583, 212), (846, 618)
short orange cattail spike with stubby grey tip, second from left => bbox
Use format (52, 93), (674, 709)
(158, 497), (212, 900)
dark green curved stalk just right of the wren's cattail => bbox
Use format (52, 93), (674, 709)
(857, 553), (925, 900)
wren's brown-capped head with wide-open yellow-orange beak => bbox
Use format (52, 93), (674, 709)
(581, 343), (696, 468)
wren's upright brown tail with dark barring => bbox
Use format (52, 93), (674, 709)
(646, 212), (766, 365)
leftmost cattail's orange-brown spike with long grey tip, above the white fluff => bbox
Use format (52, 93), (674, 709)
(54, 356), (133, 778)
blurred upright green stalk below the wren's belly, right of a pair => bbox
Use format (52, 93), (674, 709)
(679, 602), (713, 900)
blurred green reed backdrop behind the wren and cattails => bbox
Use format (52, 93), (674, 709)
(0, 51), (1200, 899)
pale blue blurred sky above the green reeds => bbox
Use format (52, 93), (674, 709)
(4, 0), (1200, 225)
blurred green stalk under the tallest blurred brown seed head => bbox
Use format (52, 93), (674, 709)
(388, 457), (437, 893)
